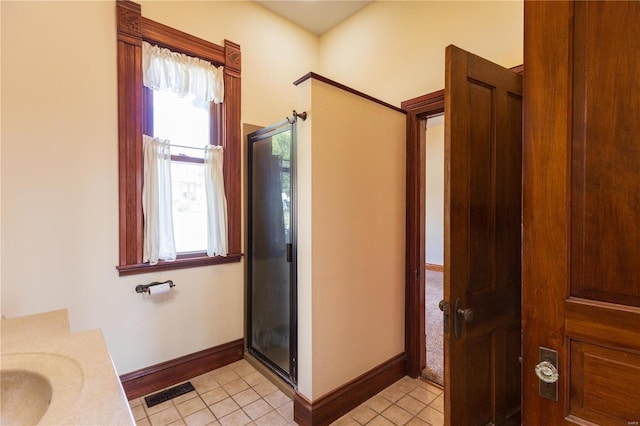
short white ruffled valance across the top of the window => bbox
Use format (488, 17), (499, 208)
(142, 41), (224, 104)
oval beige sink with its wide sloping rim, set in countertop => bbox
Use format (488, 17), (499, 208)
(0, 352), (83, 425)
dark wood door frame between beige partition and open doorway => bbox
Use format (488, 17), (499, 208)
(402, 90), (444, 377)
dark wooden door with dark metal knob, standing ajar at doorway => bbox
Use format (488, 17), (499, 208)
(444, 46), (522, 426)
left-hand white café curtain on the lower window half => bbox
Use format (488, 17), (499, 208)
(142, 135), (176, 265)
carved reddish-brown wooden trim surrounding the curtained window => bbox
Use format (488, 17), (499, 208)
(116, 0), (242, 275)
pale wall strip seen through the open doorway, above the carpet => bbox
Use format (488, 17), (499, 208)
(425, 120), (444, 265)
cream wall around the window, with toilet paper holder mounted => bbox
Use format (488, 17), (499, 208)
(1, 1), (318, 374)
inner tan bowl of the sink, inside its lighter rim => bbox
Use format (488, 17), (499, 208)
(0, 369), (52, 425)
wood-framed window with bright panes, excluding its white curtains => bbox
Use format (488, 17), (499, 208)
(116, 1), (242, 275)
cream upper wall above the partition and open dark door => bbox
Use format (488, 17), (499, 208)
(320, 1), (524, 106)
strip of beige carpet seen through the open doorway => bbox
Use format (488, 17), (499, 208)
(422, 270), (444, 386)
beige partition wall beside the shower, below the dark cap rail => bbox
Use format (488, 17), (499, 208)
(298, 80), (406, 400)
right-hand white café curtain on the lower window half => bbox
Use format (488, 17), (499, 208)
(204, 145), (229, 256)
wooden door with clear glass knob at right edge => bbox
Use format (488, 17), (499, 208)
(522, 1), (640, 425)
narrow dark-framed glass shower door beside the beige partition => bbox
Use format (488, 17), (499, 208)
(247, 122), (297, 384)
